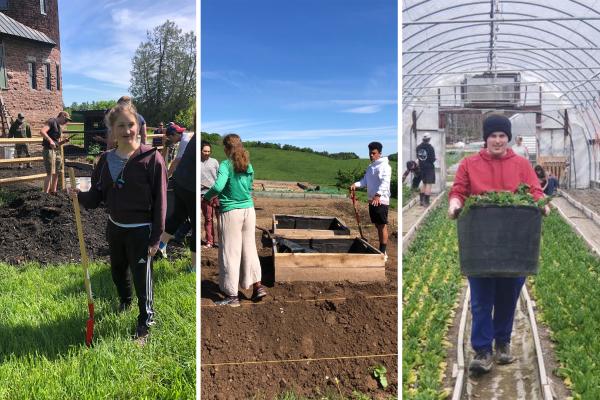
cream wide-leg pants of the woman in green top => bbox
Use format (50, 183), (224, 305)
(219, 207), (261, 296)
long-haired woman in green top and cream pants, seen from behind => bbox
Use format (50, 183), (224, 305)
(202, 133), (267, 307)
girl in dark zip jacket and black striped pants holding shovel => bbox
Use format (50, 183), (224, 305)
(69, 103), (167, 344)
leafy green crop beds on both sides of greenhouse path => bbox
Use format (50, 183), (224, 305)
(402, 204), (600, 400)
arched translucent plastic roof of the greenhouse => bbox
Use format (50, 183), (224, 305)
(402, 0), (600, 111)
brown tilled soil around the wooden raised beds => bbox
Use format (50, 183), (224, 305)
(201, 198), (398, 399)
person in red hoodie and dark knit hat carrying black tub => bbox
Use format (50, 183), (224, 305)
(448, 115), (550, 374)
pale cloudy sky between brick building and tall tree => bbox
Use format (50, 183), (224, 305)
(58, 0), (196, 106)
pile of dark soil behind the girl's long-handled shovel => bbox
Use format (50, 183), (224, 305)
(0, 185), (108, 264)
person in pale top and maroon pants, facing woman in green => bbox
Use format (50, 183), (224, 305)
(200, 141), (219, 248)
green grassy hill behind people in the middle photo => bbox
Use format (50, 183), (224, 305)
(212, 144), (398, 186)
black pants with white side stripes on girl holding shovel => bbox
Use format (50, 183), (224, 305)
(106, 221), (154, 326)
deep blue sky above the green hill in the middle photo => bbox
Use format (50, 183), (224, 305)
(200, 0), (398, 158)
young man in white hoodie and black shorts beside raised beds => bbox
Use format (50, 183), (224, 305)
(350, 142), (392, 260)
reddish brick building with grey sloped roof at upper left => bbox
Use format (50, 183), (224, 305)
(0, 0), (63, 132)
